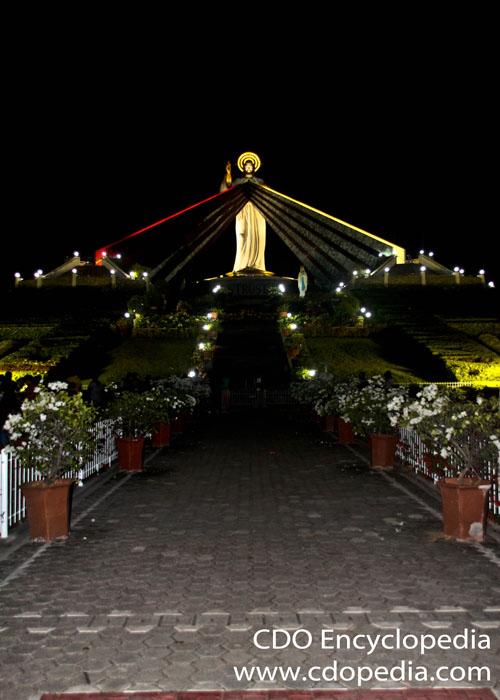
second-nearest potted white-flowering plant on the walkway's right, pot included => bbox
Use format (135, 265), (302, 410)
(338, 375), (407, 462)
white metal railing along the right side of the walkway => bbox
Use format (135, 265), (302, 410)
(396, 428), (500, 520)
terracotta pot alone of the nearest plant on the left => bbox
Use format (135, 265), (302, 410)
(21, 479), (74, 542)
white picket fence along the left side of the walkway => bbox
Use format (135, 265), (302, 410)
(0, 420), (117, 538)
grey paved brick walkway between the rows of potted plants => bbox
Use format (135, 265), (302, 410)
(0, 411), (500, 700)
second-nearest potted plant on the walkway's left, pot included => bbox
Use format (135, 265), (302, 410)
(107, 391), (155, 471)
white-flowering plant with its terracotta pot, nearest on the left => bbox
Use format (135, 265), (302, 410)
(4, 382), (96, 541)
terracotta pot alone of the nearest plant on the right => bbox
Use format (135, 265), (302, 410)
(439, 477), (491, 542)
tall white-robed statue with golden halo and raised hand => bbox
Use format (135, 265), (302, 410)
(221, 152), (269, 274)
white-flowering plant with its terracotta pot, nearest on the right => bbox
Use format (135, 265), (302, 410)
(396, 384), (500, 541)
